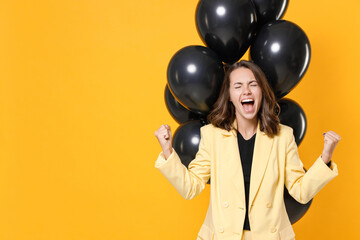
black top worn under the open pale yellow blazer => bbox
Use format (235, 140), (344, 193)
(237, 132), (331, 230)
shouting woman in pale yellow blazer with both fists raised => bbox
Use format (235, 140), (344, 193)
(155, 61), (340, 240)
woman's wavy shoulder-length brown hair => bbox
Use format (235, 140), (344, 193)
(208, 60), (280, 137)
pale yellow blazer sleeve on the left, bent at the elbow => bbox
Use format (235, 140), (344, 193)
(155, 126), (211, 199)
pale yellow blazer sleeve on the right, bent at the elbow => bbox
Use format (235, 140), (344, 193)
(285, 129), (338, 204)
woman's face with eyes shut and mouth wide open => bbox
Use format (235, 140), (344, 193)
(229, 67), (262, 120)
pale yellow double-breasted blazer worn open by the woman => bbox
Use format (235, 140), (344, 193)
(155, 124), (338, 240)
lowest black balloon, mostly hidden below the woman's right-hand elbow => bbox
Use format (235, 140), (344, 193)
(284, 177), (312, 224)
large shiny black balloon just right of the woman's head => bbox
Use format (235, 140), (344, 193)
(250, 20), (311, 98)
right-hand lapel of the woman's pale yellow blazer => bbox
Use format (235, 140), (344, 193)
(249, 124), (273, 209)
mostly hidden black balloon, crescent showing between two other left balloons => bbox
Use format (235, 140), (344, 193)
(164, 85), (206, 124)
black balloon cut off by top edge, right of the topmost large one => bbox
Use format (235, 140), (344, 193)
(252, 0), (289, 26)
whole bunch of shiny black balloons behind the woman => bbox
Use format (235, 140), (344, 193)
(165, 0), (311, 223)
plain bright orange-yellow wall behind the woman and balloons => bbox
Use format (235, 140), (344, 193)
(0, 0), (360, 240)
